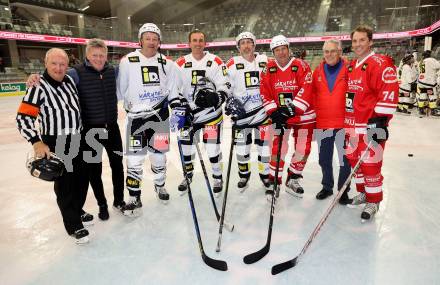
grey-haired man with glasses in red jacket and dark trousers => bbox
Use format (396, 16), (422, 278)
(312, 39), (350, 204)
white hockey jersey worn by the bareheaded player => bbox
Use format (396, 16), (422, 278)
(176, 51), (230, 124)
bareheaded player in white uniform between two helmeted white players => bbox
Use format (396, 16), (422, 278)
(176, 30), (230, 197)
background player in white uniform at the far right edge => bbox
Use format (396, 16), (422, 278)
(417, 50), (440, 116)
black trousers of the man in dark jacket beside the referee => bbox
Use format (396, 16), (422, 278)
(80, 122), (124, 206)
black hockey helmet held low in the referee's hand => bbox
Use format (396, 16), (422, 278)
(26, 153), (64, 181)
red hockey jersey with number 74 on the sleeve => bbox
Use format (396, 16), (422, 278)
(344, 52), (399, 134)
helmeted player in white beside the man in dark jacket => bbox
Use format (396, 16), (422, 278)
(117, 23), (179, 216)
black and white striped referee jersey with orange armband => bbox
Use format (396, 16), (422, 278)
(17, 71), (82, 144)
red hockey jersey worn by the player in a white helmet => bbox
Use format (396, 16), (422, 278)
(260, 58), (316, 125)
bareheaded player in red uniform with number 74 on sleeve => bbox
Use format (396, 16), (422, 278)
(344, 25), (399, 221)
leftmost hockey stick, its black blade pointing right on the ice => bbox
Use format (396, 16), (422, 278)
(177, 134), (228, 271)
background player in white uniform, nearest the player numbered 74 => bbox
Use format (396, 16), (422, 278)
(397, 54), (417, 114)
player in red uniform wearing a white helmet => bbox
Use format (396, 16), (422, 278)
(260, 35), (316, 200)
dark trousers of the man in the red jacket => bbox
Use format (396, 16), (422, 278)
(315, 129), (351, 192)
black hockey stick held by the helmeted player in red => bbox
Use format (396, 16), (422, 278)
(243, 127), (284, 264)
